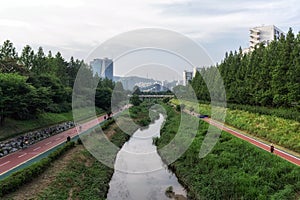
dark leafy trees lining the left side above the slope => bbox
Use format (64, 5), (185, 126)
(0, 40), (122, 125)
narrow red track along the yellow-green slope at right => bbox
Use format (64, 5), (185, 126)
(203, 118), (300, 166)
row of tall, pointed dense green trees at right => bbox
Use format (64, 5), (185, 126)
(191, 29), (300, 108)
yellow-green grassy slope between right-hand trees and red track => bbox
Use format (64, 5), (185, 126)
(171, 99), (300, 154)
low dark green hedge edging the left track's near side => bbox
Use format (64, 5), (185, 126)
(0, 142), (75, 197)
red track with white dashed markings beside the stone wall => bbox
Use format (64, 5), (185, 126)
(0, 115), (104, 176)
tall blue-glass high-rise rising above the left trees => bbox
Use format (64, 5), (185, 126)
(90, 58), (114, 80)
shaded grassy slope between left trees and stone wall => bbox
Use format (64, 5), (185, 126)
(0, 109), (105, 141)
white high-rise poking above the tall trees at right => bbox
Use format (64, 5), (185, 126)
(243, 25), (284, 53)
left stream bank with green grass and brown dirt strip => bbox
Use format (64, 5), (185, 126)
(4, 104), (159, 199)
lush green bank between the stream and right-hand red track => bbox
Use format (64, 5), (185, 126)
(156, 106), (300, 199)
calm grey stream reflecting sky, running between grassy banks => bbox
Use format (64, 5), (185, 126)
(107, 115), (186, 200)
